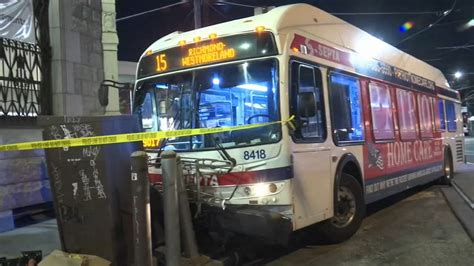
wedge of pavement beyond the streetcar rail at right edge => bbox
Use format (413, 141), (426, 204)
(441, 163), (474, 241)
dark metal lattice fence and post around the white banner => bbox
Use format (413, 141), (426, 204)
(0, 0), (52, 118)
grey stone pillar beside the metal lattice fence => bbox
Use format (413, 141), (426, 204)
(49, 0), (104, 116)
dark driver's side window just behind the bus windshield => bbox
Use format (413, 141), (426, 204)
(290, 62), (326, 141)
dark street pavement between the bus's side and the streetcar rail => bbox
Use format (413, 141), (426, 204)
(268, 185), (474, 266)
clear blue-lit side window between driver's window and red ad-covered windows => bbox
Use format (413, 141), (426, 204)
(329, 73), (364, 142)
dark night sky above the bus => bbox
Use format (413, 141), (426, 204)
(117, 0), (474, 92)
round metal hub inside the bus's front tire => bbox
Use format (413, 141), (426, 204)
(332, 186), (356, 228)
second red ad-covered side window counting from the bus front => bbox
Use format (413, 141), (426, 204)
(397, 89), (416, 140)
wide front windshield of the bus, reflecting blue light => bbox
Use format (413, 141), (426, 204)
(134, 59), (281, 151)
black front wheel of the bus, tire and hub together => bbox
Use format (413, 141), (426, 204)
(317, 173), (365, 244)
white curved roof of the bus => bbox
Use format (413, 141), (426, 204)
(142, 4), (454, 91)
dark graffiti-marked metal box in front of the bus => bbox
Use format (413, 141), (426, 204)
(38, 116), (142, 265)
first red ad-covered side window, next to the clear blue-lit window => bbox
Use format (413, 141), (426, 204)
(369, 83), (395, 140)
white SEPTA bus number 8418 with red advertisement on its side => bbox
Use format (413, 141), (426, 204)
(134, 4), (463, 242)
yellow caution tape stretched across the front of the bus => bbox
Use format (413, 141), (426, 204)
(0, 116), (294, 152)
